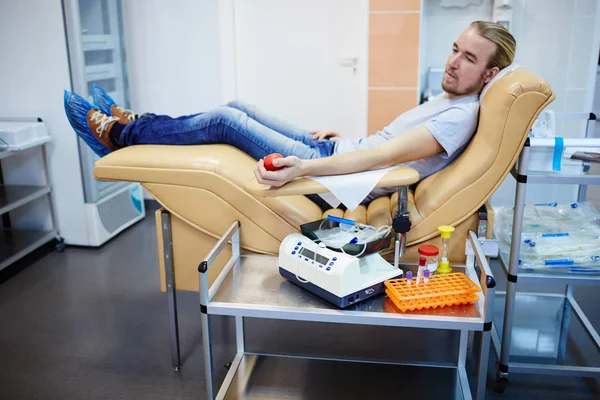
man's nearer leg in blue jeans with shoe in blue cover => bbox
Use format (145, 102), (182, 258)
(64, 91), (334, 210)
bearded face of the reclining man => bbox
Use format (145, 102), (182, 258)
(442, 28), (498, 96)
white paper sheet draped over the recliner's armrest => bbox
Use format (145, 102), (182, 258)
(307, 167), (394, 211)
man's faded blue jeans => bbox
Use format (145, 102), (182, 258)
(116, 101), (335, 160)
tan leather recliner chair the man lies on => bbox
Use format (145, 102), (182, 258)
(94, 68), (555, 291)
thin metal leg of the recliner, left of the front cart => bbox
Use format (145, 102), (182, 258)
(161, 211), (181, 371)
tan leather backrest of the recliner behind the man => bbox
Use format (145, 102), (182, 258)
(409, 65), (555, 241)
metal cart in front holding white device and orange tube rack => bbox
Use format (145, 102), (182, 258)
(168, 211), (496, 400)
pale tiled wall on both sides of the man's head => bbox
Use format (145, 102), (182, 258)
(420, 0), (598, 206)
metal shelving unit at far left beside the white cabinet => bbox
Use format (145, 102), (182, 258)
(0, 119), (64, 270)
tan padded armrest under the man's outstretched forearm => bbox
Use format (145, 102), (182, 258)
(246, 167), (419, 197)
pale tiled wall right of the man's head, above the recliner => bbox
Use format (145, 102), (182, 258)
(492, 0), (599, 206)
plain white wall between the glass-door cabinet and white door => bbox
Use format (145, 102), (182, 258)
(124, 0), (222, 116)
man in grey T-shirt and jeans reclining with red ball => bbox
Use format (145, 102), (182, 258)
(64, 21), (516, 207)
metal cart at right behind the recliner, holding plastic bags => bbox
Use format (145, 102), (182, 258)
(492, 114), (600, 392)
